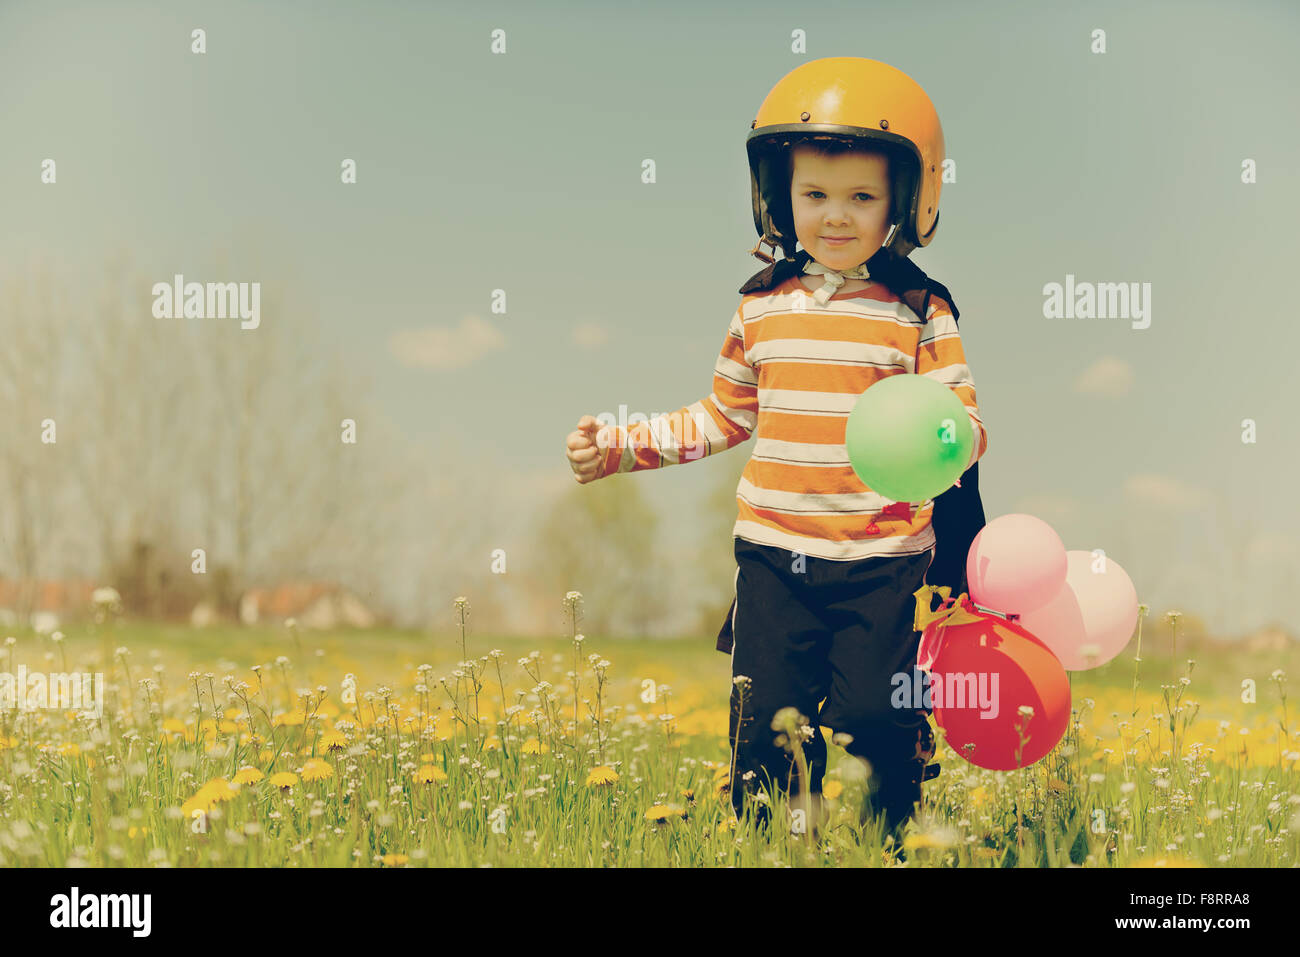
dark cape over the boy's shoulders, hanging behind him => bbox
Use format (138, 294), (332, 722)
(718, 248), (984, 654)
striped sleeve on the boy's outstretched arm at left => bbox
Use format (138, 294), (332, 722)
(597, 308), (758, 475)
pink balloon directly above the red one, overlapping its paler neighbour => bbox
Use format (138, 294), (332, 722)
(966, 512), (1066, 615)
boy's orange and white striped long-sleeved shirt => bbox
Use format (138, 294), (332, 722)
(598, 276), (988, 562)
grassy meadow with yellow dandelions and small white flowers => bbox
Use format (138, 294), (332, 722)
(0, 593), (1300, 867)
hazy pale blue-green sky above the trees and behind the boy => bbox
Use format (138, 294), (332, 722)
(0, 0), (1300, 642)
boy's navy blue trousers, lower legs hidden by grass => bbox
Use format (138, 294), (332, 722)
(729, 538), (939, 833)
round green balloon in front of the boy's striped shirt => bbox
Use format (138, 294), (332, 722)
(844, 373), (975, 502)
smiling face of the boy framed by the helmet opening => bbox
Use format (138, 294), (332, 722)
(790, 147), (889, 270)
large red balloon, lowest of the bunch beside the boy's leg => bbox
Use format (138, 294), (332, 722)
(923, 605), (1070, 771)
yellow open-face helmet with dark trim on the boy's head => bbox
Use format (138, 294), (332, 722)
(745, 56), (944, 263)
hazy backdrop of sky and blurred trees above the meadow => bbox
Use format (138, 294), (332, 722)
(0, 0), (1300, 641)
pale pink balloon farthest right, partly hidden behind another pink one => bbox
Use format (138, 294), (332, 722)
(1019, 550), (1138, 671)
